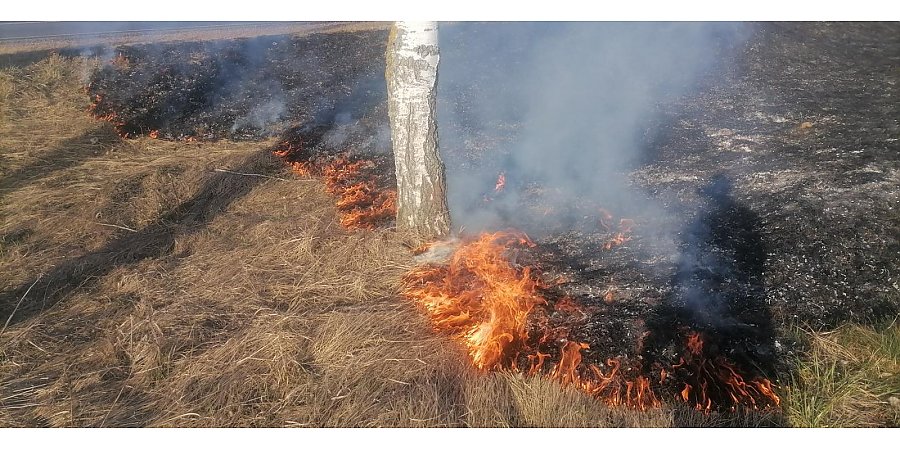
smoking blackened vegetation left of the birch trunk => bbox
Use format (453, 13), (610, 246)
(88, 28), (386, 139)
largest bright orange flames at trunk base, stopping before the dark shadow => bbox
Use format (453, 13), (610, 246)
(404, 231), (659, 409)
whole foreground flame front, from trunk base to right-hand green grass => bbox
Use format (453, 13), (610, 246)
(403, 231), (780, 411)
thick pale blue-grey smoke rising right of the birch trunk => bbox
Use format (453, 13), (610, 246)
(438, 23), (748, 236)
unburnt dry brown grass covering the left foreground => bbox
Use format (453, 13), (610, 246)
(0, 51), (788, 427)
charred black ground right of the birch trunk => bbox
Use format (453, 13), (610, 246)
(445, 23), (900, 412)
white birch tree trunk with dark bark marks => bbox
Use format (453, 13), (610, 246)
(385, 22), (450, 240)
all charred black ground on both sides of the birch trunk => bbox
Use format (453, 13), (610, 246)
(81, 23), (900, 412)
